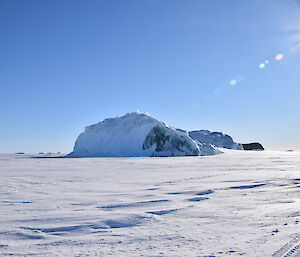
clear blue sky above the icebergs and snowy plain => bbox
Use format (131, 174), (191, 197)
(0, 0), (300, 152)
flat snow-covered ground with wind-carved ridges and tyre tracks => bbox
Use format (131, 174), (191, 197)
(0, 150), (300, 257)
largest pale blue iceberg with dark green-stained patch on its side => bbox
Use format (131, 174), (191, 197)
(67, 112), (221, 157)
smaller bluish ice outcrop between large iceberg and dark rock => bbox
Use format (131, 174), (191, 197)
(189, 130), (243, 150)
